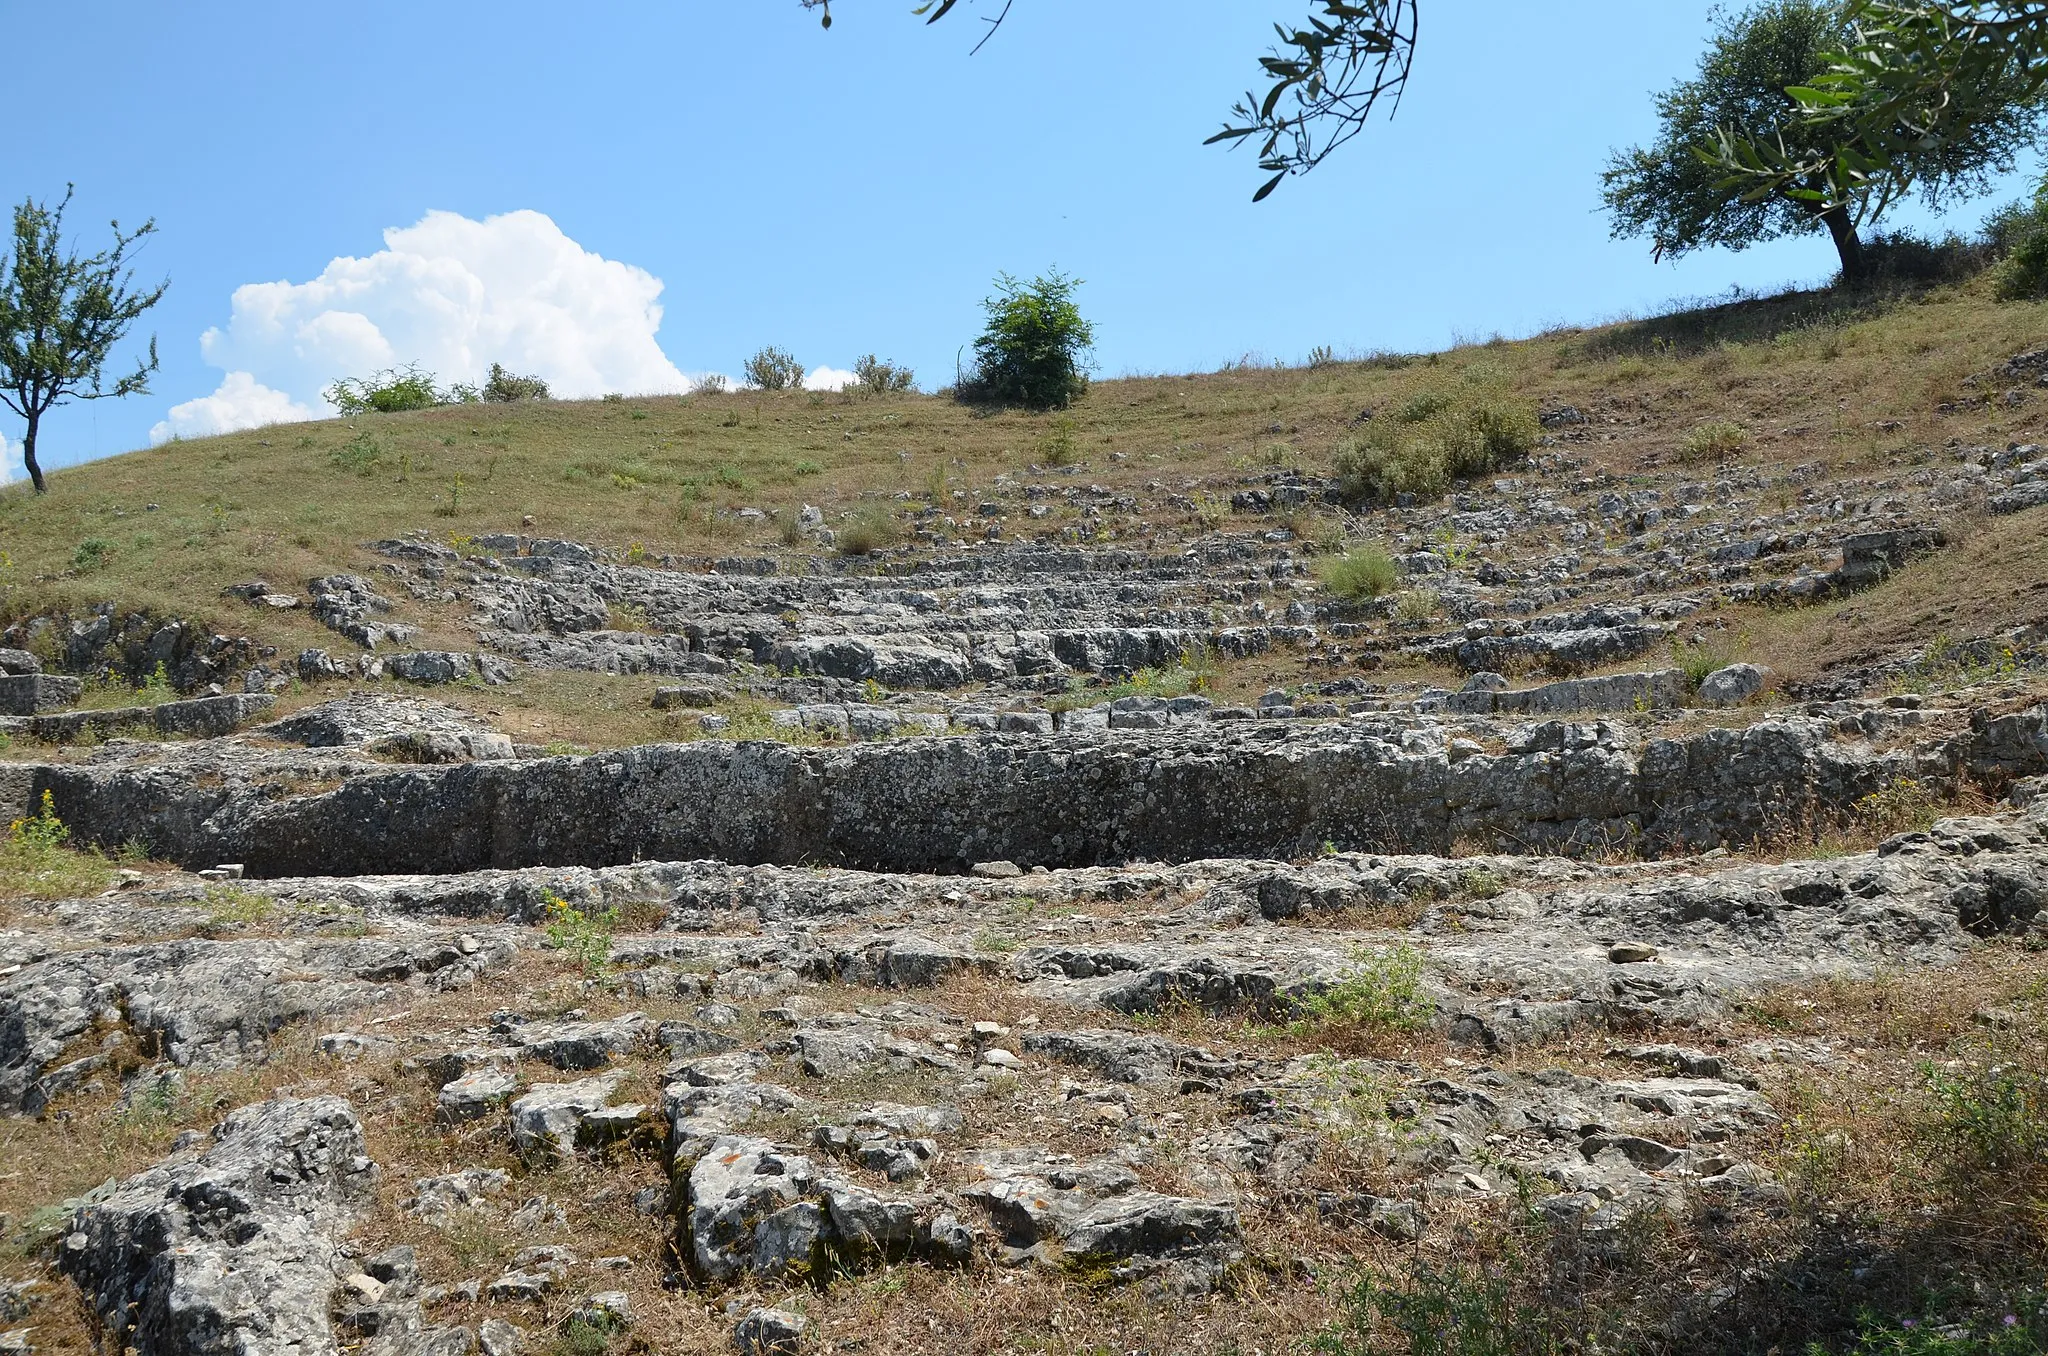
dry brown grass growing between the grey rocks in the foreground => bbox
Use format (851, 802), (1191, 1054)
(12, 897), (2048, 1356)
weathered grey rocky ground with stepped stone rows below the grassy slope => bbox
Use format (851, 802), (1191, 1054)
(0, 354), (2048, 1356)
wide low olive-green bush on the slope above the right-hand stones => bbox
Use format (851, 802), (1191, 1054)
(1335, 391), (1538, 504)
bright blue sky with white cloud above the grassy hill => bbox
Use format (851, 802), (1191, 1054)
(0, 0), (2032, 473)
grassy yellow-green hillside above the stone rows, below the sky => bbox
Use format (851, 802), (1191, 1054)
(0, 279), (2048, 737)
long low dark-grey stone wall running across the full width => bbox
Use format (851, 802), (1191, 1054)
(28, 707), (2048, 877)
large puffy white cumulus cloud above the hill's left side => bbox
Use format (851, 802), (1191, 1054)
(152, 211), (690, 440)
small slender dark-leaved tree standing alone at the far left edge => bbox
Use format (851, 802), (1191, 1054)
(0, 188), (170, 494)
